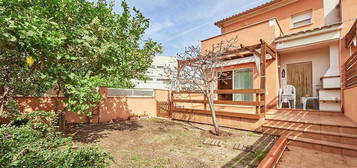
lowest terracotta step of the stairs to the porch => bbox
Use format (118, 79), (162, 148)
(288, 136), (357, 157)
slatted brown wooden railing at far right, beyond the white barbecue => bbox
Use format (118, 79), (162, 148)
(343, 52), (357, 87)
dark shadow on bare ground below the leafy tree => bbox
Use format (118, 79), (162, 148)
(67, 121), (143, 143)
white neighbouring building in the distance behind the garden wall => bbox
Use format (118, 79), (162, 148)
(134, 56), (177, 90)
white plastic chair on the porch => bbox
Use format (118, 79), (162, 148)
(279, 85), (296, 109)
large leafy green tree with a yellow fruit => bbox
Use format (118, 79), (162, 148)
(0, 0), (161, 129)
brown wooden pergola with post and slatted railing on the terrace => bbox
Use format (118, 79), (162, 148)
(173, 39), (278, 119)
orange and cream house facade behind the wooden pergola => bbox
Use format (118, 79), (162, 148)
(202, 0), (357, 118)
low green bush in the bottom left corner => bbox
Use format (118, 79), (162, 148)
(0, 112), (111, 168)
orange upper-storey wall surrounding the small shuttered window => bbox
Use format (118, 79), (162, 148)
(222, 0), (325, 34)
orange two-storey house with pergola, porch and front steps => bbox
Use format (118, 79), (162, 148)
(172, 0), (357, 164)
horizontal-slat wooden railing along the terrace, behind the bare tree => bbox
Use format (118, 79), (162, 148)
(170, 89), (265, 119)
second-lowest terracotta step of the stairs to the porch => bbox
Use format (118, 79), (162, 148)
(263, 124), (357, 145)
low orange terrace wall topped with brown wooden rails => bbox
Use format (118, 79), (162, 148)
(171, 89), (265, 130)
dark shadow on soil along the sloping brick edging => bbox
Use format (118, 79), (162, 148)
(222, 134), (277, 168)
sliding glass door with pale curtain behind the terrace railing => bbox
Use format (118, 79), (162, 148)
(233, 68), (253, 101)
